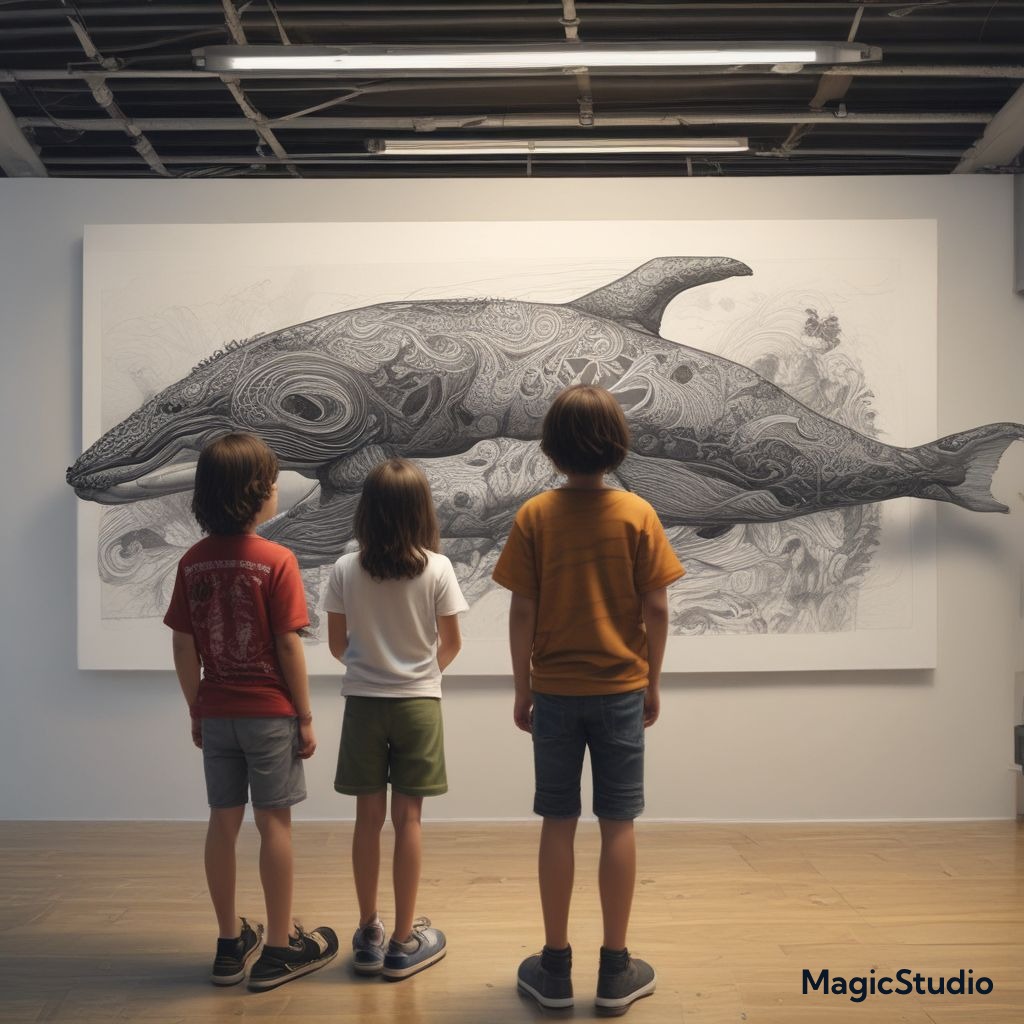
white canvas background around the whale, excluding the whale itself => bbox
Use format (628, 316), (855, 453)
(79, 220), (937, 675)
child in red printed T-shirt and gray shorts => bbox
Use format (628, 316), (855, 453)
(164, 434), (338, 990)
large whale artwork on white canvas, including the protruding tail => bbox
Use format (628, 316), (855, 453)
(69, 221), (1024, 674)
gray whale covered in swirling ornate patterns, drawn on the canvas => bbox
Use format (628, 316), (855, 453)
(67, 256), (1024, 630)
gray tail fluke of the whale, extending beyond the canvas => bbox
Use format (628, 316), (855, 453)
(913, 423), (1024, 512)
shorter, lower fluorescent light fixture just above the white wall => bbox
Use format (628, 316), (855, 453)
(368, 137), (749, 157)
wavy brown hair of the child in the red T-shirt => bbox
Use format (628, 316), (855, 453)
(193, 434), (278, 534)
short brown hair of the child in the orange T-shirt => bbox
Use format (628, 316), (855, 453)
(541, 384), (630, 475)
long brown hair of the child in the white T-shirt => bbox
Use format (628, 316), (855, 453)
(354, 459), (440, 580)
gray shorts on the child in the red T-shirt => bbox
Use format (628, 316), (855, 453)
(203, 718), (306, 809)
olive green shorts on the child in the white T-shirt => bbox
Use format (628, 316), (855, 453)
(334, 697), (447, 797)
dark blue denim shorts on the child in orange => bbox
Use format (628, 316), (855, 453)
(534, 690), (645, 821)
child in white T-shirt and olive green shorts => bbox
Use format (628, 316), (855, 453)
(324, 459), (469, 981)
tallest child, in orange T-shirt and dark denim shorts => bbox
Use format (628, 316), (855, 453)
(494, 385), (684, 1015)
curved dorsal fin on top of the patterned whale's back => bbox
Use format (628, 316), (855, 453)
(565, 256), (754, 334)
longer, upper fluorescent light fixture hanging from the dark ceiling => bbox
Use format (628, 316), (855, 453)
(193, 42), (882, 76)
